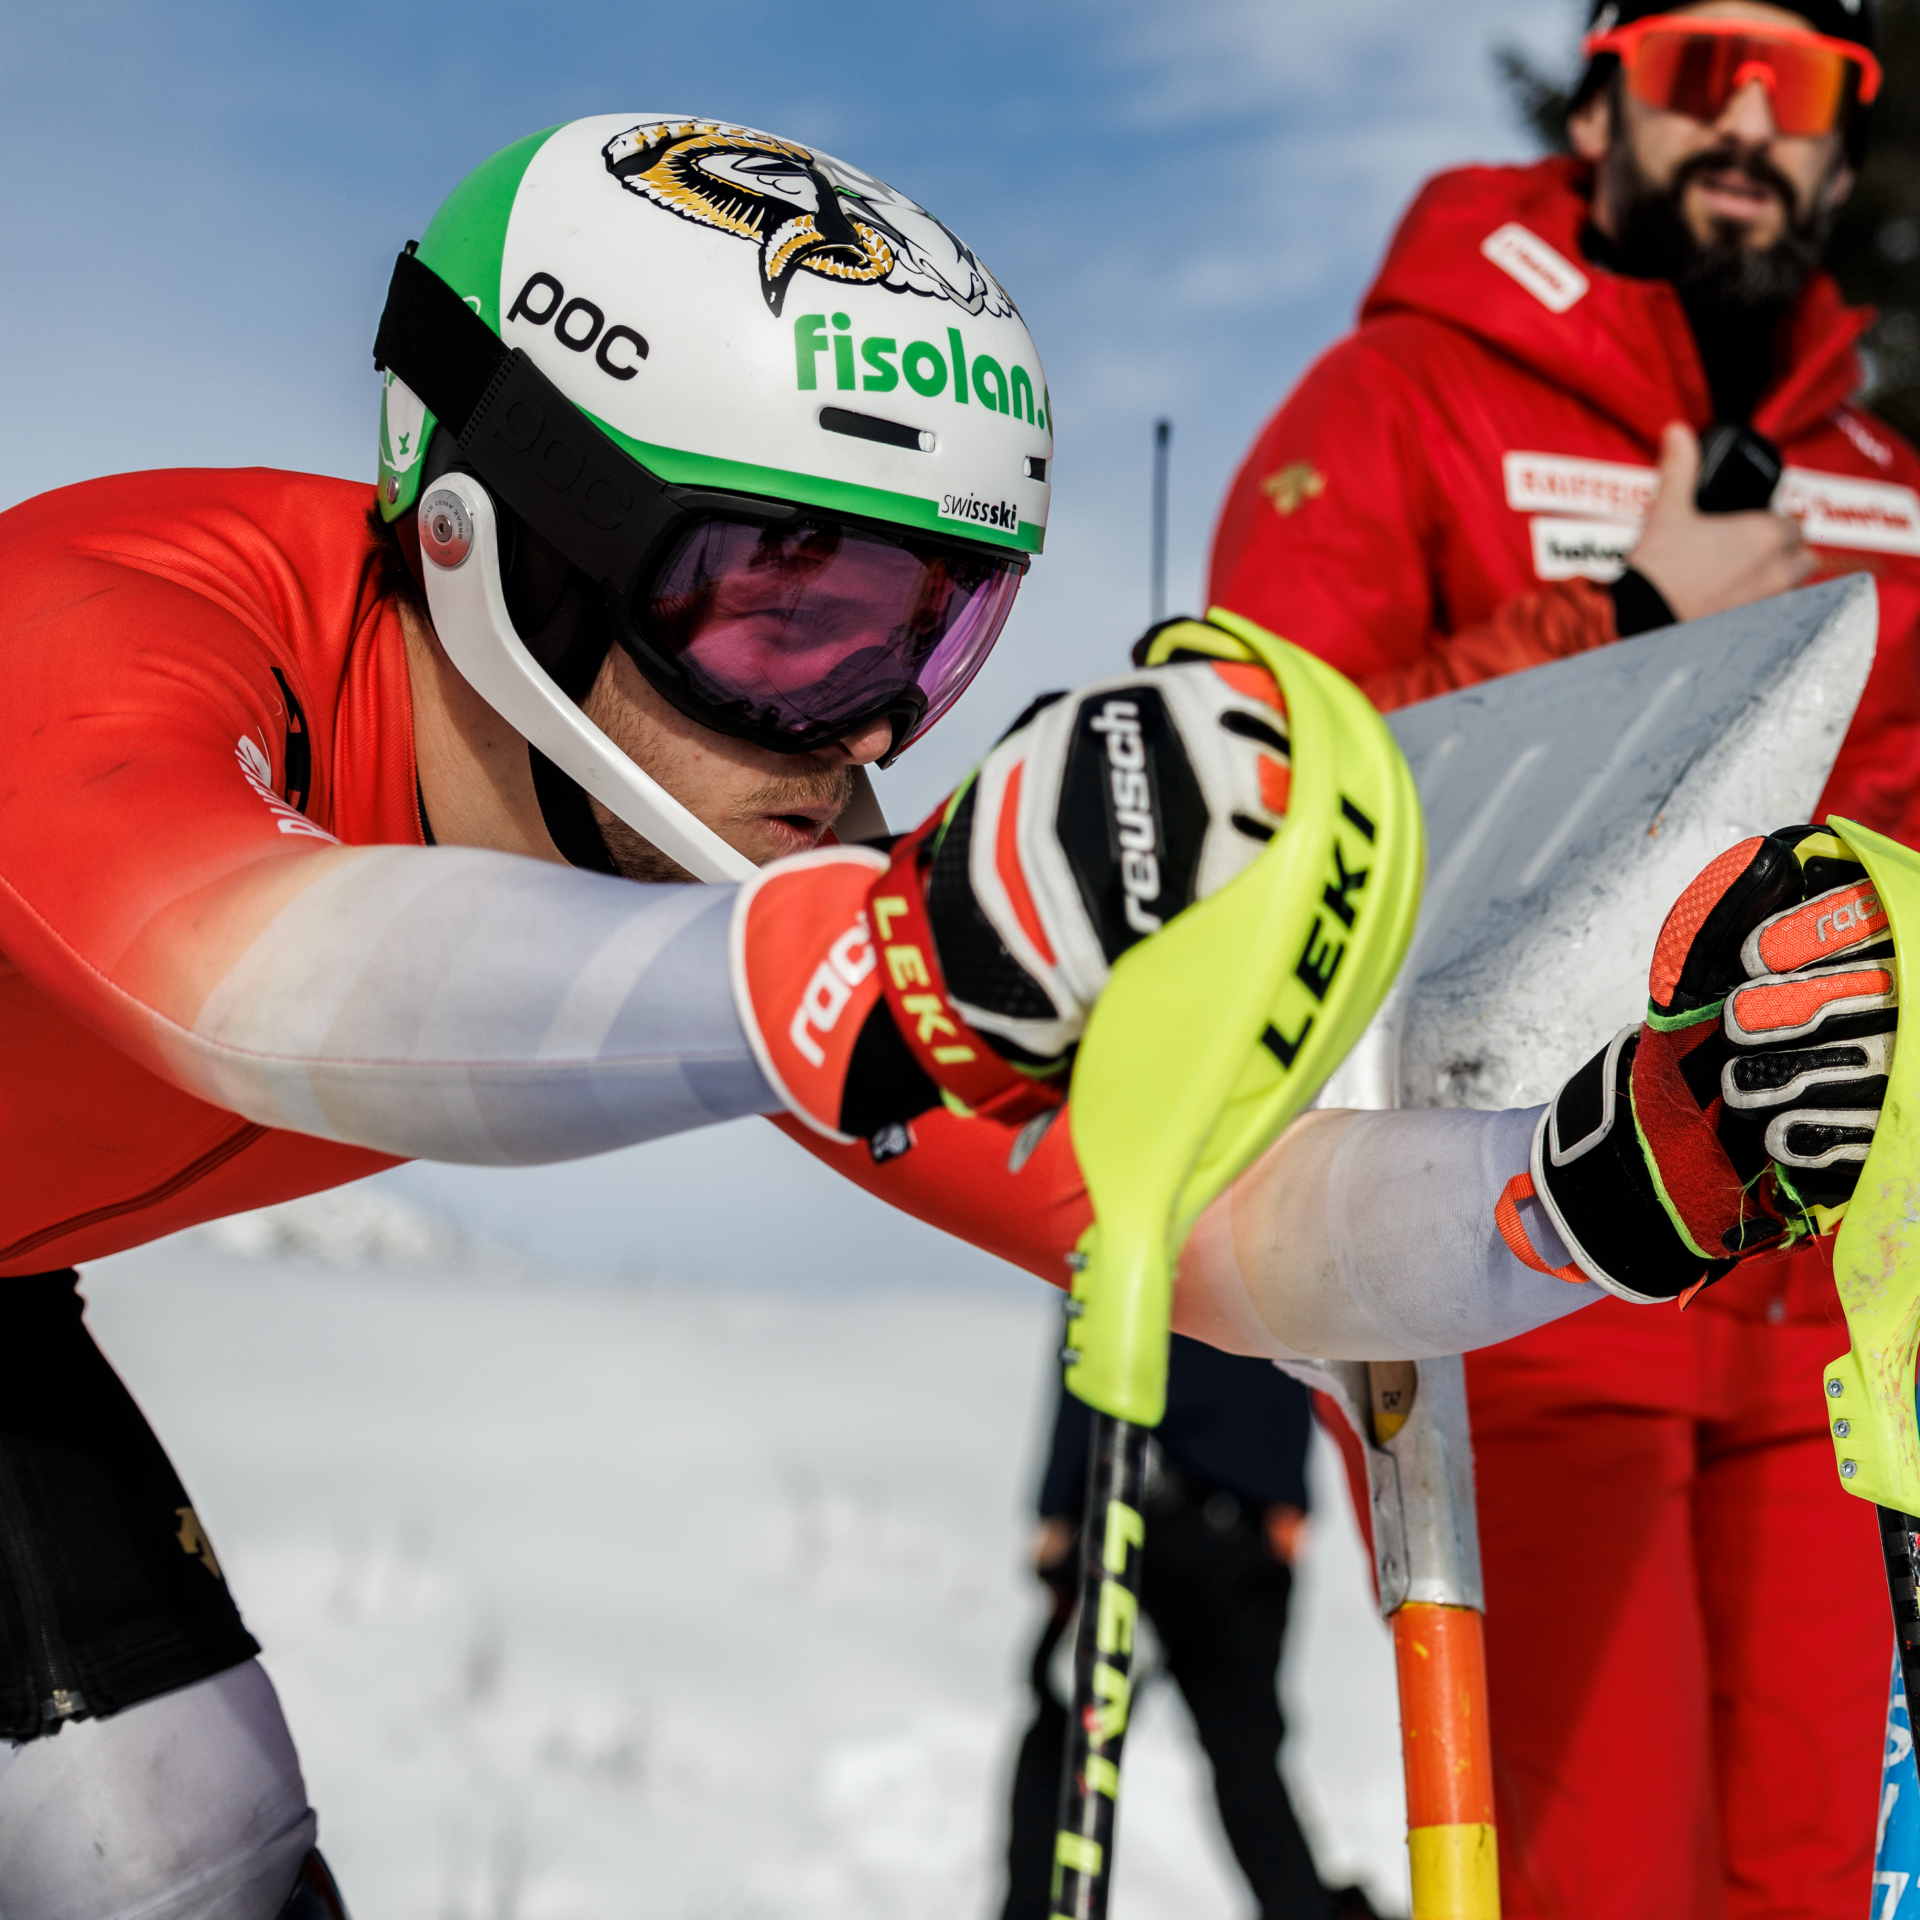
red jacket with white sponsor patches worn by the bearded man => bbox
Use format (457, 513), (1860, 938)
(1210, 159), (1920, 843)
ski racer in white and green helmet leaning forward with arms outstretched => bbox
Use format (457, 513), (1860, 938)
(0, 115), (1884, 1920)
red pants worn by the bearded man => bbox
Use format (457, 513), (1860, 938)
(1467, 1252), (1893, 1920)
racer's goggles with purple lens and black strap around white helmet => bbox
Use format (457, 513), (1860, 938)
(374, 253), (1027, 764)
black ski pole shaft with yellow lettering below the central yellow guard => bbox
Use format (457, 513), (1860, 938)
(1052, 1413), (1148, 1920)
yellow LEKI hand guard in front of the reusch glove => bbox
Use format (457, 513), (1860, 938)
(1066, 609), (1427, 1427)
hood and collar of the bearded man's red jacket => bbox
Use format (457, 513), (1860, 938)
(1359, 157), (1872, 442)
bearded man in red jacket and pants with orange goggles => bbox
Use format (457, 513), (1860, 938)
(1212, 0), (1920, 1920)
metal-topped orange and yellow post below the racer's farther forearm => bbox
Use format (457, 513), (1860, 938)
(1352, 1359), (1500, 1920)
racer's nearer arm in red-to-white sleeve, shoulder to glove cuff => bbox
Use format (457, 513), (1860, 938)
(0, 553), (778, 1164)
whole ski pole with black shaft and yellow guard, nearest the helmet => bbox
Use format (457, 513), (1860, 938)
(1052, 612), (1423, 1920)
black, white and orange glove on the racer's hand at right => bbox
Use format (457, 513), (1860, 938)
(1501, 826), (1897, 1302)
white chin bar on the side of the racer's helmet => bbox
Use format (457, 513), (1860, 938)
(420, 472), (756, 881)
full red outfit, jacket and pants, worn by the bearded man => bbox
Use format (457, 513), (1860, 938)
(1210, 159), (1896, 1920)
